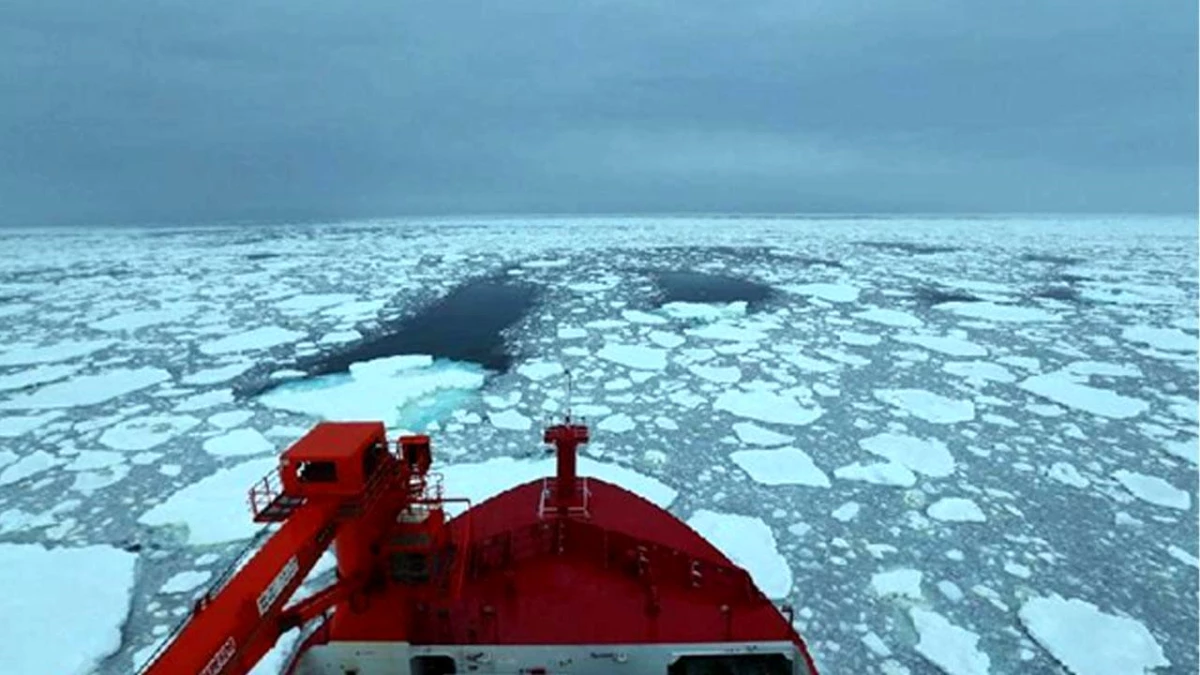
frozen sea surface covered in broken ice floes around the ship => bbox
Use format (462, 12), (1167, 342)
(0, 217), (1200, 675)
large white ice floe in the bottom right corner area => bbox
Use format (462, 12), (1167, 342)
(1018, 595), (1171, 675)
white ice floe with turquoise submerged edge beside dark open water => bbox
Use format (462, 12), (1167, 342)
(259, 354), (488, 431)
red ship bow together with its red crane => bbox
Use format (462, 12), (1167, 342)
(136, 414), (816, 675)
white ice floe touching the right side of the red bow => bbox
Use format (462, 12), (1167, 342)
(688, 509), (792, 598)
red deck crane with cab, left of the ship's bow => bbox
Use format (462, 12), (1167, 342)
(142, 422), (461, 675)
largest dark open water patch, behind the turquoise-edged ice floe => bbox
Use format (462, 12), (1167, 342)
(298, 279), (539, 376)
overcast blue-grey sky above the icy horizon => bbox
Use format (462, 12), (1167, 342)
(0, 0), (1198, 225)
